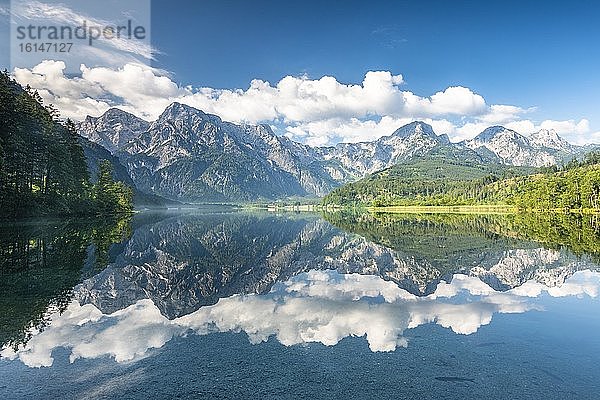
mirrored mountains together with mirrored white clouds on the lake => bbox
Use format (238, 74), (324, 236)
(1, 212), (600, 366)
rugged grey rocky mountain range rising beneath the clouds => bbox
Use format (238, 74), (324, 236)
(78, 103), (592, 203)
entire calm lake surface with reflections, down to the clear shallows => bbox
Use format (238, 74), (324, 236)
(0, 213), (600, 399)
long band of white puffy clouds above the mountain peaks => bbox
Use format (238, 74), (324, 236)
(14, 61), (600, 145)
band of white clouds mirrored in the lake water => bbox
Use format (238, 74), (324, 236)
(0, 271), (600, 367)
